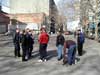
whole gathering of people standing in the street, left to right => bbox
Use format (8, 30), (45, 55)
(14, 27), (85, 65)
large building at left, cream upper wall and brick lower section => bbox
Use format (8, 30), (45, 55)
(10, 0), (49, 29)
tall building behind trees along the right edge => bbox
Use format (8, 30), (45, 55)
(80, 0), (100, 40)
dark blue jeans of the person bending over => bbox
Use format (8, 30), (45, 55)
(68, 45), (76, 65)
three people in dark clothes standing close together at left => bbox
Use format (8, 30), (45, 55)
(13, 29), (34, 61)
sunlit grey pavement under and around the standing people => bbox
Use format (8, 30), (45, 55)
(0, 35), (100, 75)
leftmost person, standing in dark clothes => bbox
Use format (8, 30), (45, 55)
(13, 29), (21, 57)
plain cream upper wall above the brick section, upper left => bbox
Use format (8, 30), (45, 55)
(10, 0), (49, 15)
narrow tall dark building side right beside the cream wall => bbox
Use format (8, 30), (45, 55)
(49, 0), (58, 33)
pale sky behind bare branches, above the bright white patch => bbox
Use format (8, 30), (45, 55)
(55, 0), (75, 21)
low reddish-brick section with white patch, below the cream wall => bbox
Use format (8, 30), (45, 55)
(9, 13), (46, 30)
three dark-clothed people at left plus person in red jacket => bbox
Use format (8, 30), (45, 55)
(13, 27), (49, 62)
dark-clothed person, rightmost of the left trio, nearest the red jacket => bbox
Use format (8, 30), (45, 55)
(29, 30), (34, 58)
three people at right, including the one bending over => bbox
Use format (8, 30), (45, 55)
(56, 30), (85, 65)
